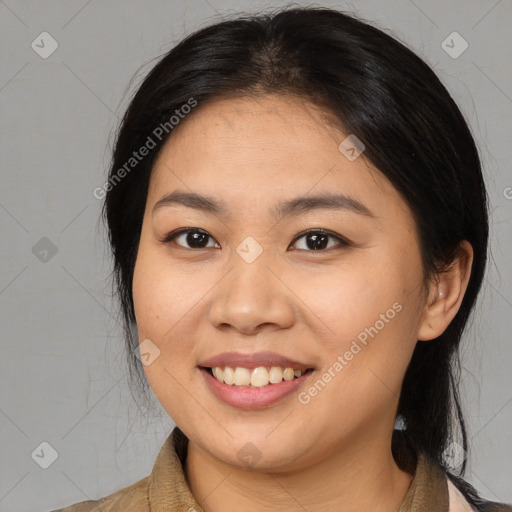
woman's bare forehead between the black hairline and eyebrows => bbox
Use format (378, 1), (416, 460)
(148, 96), (404, 221)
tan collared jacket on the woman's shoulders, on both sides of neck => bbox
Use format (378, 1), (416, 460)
(53, 427), (512, 512)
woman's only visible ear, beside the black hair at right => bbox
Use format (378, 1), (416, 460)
(417, 240), (473, 341)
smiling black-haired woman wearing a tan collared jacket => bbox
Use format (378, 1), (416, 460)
(52, 8), (512, 512)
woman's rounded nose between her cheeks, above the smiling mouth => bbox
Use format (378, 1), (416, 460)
(209, 253), (295, 335)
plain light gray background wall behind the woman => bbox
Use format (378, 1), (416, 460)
(0, 0), (512, 511)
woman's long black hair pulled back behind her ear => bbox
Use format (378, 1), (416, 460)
(102, 8), (488, 474)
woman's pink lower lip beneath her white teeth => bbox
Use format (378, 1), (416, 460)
(199, 368), (314, 409)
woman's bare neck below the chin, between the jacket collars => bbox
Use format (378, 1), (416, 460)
(185, 430), (412, 512)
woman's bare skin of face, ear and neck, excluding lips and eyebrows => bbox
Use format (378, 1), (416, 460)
(133, 95), (472, 512)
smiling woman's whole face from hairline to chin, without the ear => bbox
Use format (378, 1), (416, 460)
(133, 96), (426, 470)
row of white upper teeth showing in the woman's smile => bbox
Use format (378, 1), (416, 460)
(212, 366), (306, 388)
